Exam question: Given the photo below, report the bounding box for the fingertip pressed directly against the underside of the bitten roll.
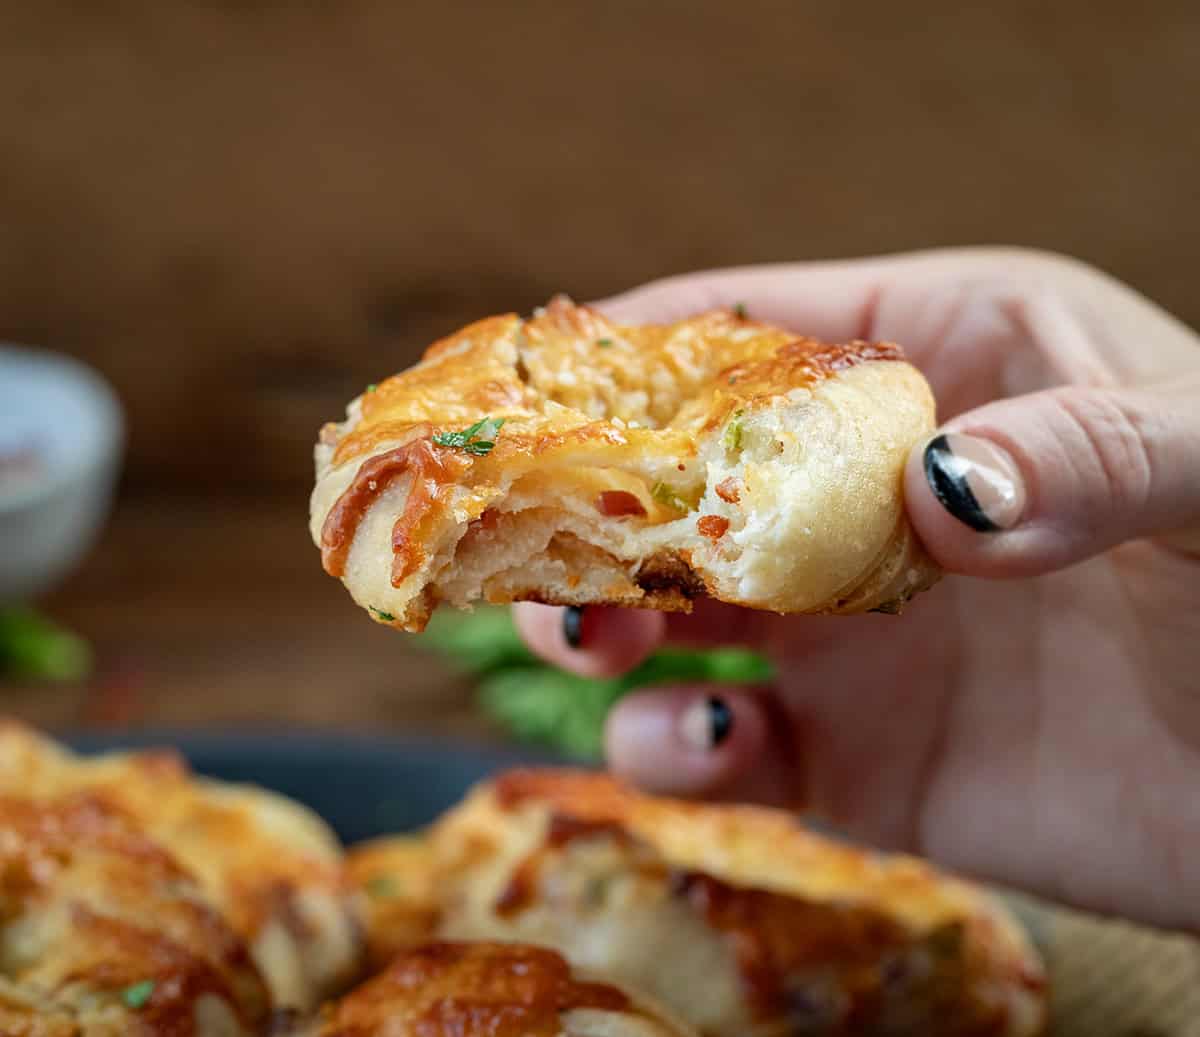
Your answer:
[512,604,666,677]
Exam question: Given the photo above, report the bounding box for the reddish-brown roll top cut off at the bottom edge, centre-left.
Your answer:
[296,943,691,1037]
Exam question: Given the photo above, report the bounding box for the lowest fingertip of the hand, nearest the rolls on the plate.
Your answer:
[605,688,802,807]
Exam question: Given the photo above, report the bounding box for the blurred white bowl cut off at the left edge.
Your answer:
[0,344,124,605]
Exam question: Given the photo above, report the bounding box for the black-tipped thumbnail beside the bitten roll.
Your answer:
[924,432,1025,533]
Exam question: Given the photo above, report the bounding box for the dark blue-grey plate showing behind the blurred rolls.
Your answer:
[62,731,553,843]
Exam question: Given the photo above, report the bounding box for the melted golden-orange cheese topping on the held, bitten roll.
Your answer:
[320,298,904,587]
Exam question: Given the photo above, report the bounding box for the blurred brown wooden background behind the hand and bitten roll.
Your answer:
[0,0,1200,733]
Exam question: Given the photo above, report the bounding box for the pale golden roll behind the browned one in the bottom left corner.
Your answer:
[0,723,362,1009]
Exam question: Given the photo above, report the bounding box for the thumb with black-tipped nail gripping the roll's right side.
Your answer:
[905,377,1200,576]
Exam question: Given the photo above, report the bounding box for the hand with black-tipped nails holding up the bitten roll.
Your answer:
[517,250,1200,928]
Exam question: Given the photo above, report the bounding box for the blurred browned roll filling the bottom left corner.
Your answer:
[0,792,271,1037]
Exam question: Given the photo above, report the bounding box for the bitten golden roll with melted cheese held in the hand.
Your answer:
[311,298,937,630]
